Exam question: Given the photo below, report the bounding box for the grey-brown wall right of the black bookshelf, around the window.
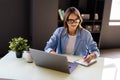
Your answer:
[99,0,120,49]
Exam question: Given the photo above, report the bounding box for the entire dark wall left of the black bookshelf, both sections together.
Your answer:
[0,0,58,57]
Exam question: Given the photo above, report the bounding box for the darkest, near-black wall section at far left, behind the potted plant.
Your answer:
[0,0,30,57]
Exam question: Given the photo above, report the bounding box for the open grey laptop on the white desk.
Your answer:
[30,48,78,74]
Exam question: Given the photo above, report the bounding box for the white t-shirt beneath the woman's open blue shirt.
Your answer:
[66,35,76,54]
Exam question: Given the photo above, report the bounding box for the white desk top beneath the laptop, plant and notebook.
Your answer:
[0,52,120,80]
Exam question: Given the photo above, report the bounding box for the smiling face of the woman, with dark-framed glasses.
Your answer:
[67,13,80,31]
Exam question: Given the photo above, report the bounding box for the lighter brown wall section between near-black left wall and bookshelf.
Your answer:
[31,0,58,50]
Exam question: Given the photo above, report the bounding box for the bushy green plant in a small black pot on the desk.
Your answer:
[9,37,30,58]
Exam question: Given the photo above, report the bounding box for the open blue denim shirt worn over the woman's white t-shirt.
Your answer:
[44,27,100,56]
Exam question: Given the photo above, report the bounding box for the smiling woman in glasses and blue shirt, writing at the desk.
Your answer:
[44,7,100,63]
